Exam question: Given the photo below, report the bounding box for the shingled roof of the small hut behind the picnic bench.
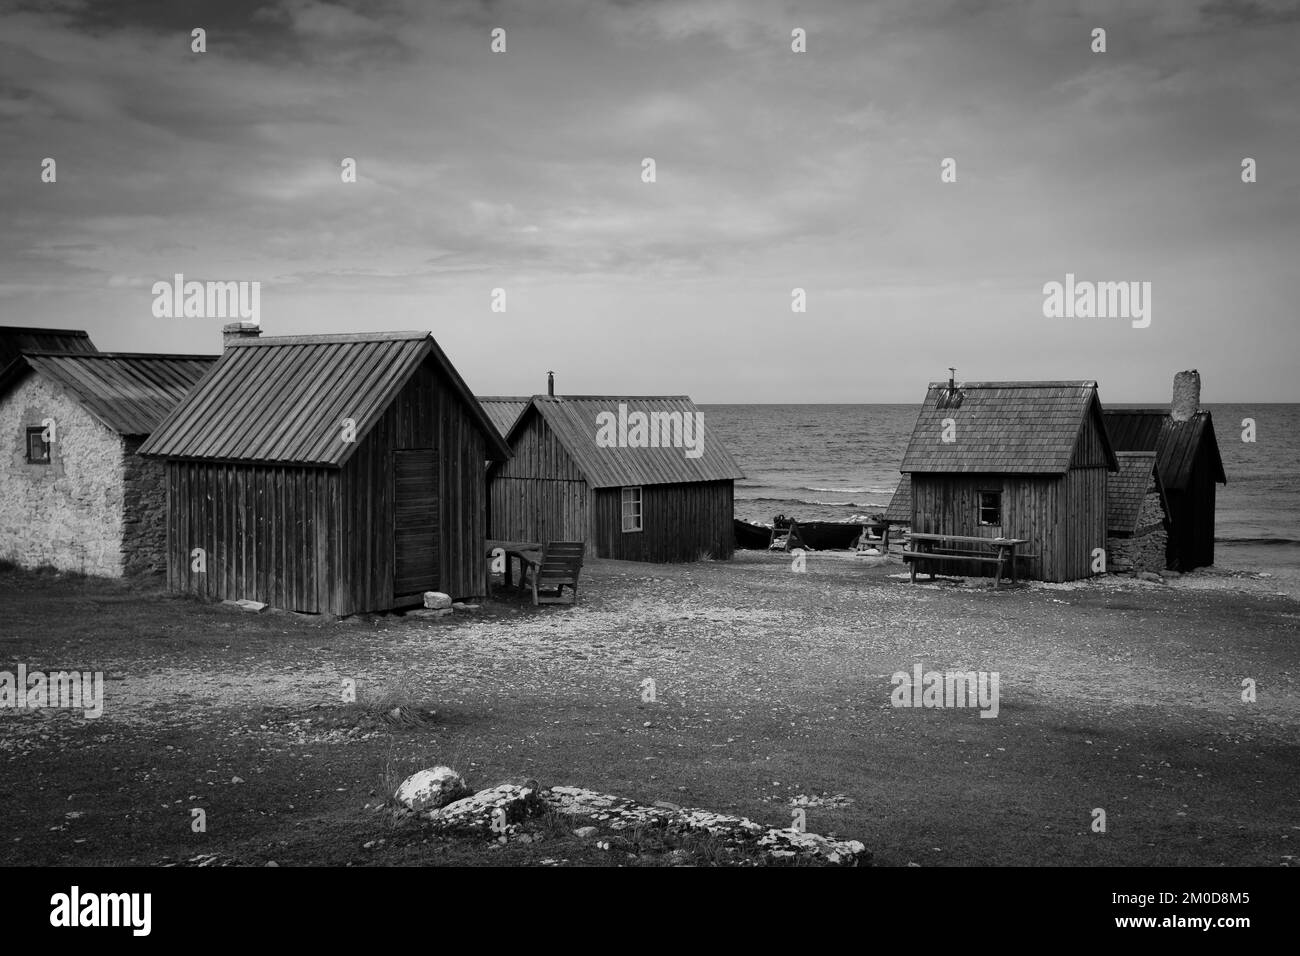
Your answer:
[900,381,1118,475]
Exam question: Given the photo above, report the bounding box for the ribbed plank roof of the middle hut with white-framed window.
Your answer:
[506,395,745,488]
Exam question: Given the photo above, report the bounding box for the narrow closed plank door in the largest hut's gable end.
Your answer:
[393,449,439,597]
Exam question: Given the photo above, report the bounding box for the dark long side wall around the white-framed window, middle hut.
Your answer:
[588,481,736,562]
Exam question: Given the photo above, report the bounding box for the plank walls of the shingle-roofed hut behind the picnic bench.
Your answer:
[911,468,1106,581]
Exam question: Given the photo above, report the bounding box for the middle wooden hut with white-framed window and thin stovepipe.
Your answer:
[488,395,744,562]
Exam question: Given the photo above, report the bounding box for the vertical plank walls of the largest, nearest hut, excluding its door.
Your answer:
[166,356,488,614]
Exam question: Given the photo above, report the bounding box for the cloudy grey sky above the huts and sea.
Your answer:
[0,0,1300,405]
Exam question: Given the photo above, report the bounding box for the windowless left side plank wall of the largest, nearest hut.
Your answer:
[166,462,339,613]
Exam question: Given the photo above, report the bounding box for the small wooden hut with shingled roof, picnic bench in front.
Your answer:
[900,380,1118,581]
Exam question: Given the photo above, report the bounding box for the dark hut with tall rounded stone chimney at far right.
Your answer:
[1106,371,1227,571]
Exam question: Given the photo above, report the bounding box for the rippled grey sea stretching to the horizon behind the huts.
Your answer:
[701,405,1300,581]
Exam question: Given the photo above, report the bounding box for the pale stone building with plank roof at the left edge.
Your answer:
[0,351,216,578]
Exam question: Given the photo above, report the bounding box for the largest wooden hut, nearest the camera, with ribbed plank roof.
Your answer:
[142,332,508,615]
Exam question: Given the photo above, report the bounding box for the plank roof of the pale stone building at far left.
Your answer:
[0,351,217,434]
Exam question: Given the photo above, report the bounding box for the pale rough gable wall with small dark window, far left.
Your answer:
[0,375,125,578]
